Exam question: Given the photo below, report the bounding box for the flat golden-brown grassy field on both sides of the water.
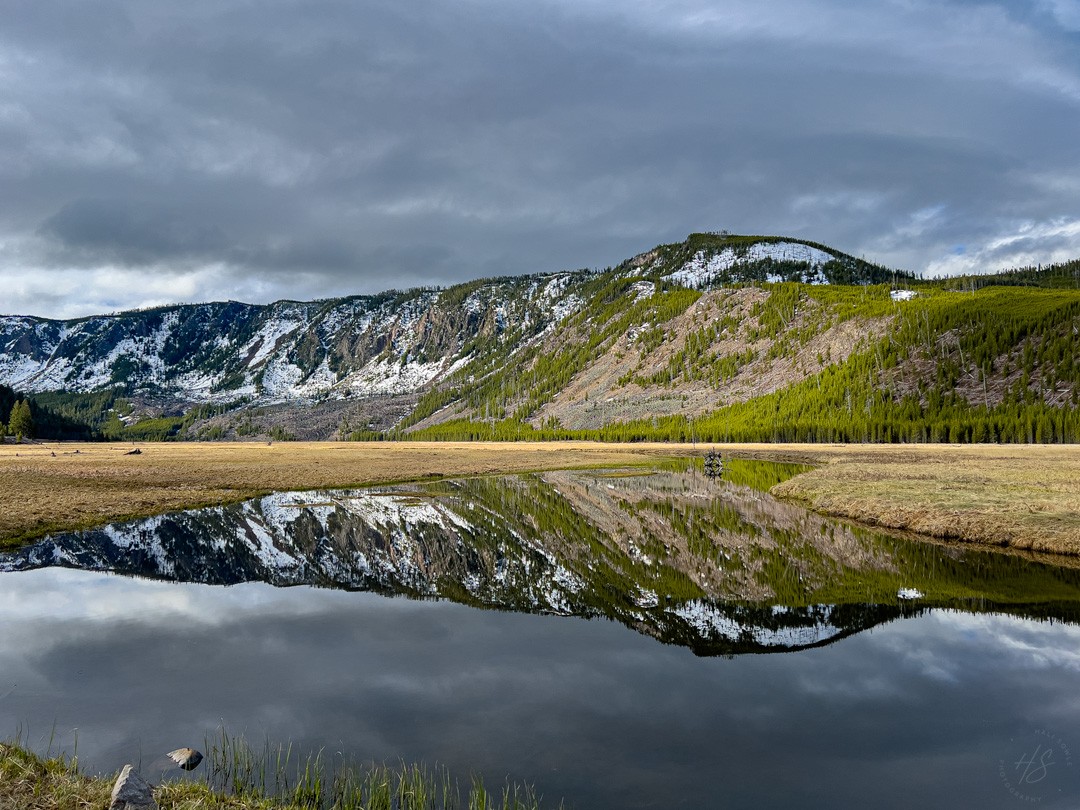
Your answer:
[0,442,1080,554]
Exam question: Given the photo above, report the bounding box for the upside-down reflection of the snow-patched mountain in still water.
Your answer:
[8,462,1080,656]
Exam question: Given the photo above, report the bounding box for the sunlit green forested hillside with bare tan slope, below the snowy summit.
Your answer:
[397,262,1080,442]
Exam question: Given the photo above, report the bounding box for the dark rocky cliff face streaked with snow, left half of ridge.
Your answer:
[0,285,548,404]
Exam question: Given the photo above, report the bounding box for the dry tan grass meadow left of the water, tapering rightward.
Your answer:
[0,442,677,545]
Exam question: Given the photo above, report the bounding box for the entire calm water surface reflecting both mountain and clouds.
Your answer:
[0,464,1080,808]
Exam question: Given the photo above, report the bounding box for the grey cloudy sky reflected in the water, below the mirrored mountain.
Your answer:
[0,568,1080,810]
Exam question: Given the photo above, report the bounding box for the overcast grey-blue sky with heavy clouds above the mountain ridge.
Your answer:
[0,0,1080,318]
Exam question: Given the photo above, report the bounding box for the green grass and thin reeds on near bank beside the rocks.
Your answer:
[0,732,540,810]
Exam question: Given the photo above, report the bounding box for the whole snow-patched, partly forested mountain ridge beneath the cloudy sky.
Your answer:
[0,233,1080,441]
